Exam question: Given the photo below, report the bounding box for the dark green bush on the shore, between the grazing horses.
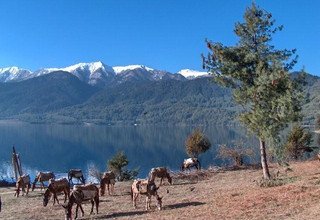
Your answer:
[107,151,139,181]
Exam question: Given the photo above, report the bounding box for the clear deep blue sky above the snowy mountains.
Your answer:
[0,0,320,75]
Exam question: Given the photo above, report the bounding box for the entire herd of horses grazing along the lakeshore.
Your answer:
[11,158,201,220]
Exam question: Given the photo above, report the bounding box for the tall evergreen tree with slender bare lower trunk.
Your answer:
[203,3,302,179]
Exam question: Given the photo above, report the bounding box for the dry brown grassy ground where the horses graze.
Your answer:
[0,161,320,220]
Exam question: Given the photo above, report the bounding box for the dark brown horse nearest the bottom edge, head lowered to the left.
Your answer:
[62,184,99,220]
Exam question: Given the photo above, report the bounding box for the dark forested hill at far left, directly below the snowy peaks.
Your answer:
[0,71,97,118]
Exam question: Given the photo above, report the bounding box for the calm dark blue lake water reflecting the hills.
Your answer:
[0,122,258,178]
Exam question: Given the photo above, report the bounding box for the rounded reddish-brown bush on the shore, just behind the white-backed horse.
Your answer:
[185,129,211,157]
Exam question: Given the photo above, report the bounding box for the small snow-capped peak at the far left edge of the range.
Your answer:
[0,66,32,82]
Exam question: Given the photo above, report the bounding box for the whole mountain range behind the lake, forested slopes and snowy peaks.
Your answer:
[0,62,320,125]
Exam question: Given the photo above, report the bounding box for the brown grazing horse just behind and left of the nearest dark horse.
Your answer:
[43,178,70,206]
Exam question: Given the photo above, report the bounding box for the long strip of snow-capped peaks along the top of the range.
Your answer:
[0,61,208,87]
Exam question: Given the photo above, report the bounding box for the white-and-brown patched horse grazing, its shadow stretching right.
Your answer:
[131,180,162,210]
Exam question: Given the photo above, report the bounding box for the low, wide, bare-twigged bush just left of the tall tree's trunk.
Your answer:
[218,144,254,166]
